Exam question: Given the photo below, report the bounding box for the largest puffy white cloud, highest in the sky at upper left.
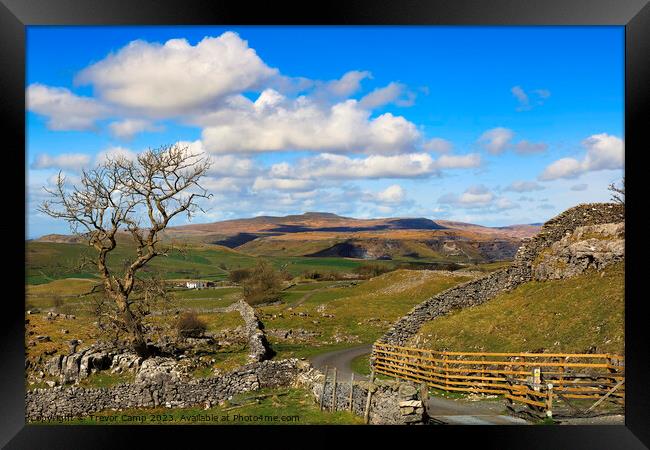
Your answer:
[77,32,278,117]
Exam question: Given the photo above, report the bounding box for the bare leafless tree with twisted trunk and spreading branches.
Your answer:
[39,145,210,357]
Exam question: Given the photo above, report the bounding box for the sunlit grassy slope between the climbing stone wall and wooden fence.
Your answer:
[415,263,625,355]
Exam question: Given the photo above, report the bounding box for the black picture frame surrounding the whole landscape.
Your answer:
[0,0,650,450]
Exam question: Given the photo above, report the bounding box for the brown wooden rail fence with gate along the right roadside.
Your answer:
[371,343,625,416]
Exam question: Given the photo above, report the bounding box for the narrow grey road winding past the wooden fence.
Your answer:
[310,344,528,425]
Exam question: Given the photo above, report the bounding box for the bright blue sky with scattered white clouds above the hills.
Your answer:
[26,26,624,238]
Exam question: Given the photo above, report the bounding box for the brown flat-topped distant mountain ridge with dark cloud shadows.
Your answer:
[39,212,539,262]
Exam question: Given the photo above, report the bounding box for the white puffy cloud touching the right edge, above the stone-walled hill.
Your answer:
[539,133,625,181]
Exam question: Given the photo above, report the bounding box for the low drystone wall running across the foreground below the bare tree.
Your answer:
[25,358,305,421]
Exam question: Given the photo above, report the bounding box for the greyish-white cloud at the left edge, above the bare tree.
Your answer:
[25,83,108,130]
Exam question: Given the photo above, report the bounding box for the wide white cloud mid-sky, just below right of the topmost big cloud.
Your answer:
[199,89,420,154]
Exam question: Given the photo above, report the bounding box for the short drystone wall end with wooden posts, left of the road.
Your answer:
[296,367,427,425]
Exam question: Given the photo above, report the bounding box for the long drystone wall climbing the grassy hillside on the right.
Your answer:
[378,203,625,345]
